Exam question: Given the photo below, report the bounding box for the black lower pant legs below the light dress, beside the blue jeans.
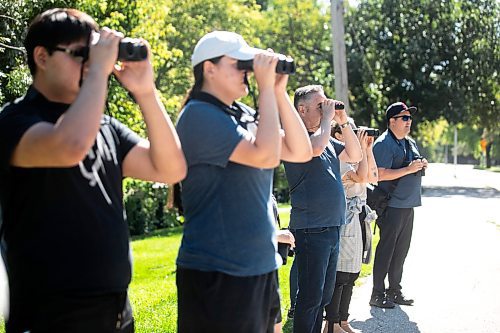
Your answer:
[325,272,359,323]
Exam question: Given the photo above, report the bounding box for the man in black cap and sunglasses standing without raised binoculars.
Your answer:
[370,102,427,308]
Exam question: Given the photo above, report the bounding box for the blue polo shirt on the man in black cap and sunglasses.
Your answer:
[373,130,422,208]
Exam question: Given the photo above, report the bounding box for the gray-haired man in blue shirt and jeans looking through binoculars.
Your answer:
[284,85,362,333]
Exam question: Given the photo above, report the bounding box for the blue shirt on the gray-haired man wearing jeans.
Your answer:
[284,138,346,229]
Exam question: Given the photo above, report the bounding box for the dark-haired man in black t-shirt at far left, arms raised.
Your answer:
[0,9,186,333]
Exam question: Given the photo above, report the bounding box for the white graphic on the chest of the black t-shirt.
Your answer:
[78,131,118,205]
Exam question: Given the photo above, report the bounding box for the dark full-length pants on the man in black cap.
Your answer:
[373,207,413,295]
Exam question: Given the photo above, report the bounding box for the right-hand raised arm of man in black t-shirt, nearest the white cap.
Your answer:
[114,41,187,183]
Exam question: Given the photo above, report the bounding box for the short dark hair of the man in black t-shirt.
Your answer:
[24,8,99,75]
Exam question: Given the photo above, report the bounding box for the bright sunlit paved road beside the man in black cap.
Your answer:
[349,164,500,333]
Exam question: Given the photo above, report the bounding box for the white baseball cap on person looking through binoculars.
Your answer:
[191,31,264,67]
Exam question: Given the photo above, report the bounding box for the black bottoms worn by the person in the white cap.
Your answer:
[176,267,280,333]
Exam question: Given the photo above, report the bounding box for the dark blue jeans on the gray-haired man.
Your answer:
[292,226,340,333]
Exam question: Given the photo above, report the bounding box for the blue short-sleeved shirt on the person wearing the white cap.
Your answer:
[177,100,281,276]
